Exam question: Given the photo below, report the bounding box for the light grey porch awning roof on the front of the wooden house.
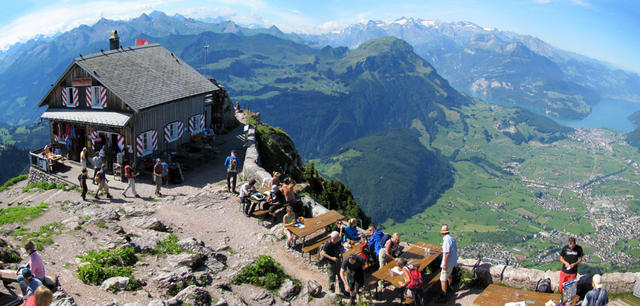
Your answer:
[40,108,131,128]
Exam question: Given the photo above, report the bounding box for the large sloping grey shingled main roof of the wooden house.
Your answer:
[74,44,218,111]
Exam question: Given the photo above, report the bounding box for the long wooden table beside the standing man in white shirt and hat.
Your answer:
[372,242,442,288]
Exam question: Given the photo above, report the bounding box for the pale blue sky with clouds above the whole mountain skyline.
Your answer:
[0,0,640,72]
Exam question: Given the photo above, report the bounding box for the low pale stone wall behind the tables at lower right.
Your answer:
[458,259,640,293]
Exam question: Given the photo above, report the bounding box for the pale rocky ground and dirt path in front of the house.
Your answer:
[0,116,488,305]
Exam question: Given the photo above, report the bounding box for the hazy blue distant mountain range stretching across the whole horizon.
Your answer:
[0,12,640,124]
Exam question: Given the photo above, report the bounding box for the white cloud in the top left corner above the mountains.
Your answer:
[0,0,167,50]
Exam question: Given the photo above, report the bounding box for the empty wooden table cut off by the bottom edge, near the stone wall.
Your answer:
[473,284,560,306]
